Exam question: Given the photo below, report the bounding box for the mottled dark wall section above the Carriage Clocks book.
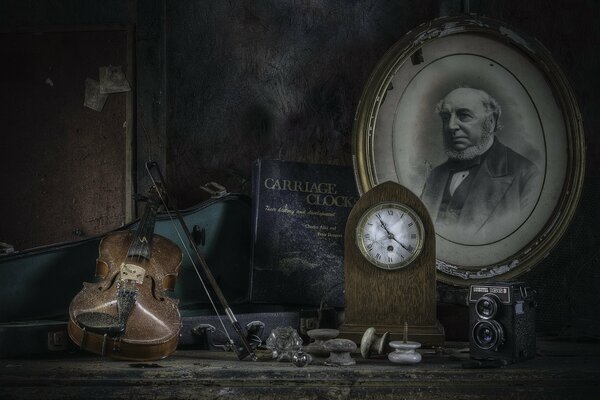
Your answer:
[166,0,435,205]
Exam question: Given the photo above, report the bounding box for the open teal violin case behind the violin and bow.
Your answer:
[0,193,290,357]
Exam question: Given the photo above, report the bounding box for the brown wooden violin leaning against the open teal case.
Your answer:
[68,185,182,361]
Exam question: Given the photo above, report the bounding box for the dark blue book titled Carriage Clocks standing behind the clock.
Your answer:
[251,160,358,307]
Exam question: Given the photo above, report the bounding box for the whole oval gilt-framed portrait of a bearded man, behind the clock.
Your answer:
[353,16,585,286]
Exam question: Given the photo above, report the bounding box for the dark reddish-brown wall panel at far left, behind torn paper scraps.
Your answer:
[0,1,135,250]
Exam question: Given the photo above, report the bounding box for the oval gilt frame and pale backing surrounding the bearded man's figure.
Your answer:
[353,16,585,286]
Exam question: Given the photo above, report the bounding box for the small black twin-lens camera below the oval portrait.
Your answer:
[469,282,536,365]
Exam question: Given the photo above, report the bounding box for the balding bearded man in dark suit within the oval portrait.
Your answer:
[421,87,543,243]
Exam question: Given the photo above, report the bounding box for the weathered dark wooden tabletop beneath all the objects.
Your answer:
[0,342,600,399]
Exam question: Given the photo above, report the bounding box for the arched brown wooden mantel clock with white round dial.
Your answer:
[340,181,444,346]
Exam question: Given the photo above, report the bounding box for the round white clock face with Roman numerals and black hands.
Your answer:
[356,202,424,269]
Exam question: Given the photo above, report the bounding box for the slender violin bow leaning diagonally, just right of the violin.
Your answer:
[146,161,258,361]
